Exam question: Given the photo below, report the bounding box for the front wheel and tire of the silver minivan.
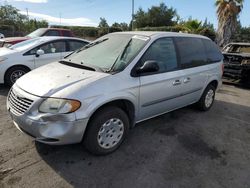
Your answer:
[83,106,129,155]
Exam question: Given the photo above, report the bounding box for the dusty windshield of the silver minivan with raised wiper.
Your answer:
[65,34,149,71]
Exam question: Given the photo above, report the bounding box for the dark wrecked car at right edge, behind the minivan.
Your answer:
[223,43,250,83]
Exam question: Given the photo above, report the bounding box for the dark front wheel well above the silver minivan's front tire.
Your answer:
[89,99,135,127]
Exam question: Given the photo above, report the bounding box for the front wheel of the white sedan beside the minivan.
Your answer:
[4,66,30,86]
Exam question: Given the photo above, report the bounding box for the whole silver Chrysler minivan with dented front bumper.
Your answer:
[7,32,223,155]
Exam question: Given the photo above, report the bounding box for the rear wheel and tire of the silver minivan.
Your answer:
[197,84,215,111]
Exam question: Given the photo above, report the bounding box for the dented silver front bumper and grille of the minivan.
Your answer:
[7,85,88,145]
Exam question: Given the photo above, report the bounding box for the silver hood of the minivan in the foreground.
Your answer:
[16,62,108,97]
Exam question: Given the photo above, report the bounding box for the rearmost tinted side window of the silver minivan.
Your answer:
[202,39,223,63]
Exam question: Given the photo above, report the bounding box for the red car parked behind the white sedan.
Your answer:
[0,28,74,47]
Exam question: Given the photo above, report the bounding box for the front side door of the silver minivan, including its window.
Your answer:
[139,38,185,121]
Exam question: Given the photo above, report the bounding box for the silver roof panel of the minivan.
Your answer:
[112,31,208,39]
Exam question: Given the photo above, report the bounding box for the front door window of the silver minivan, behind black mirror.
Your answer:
[140,38,178,72]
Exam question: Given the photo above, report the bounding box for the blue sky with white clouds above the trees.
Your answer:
[0,0,250,28]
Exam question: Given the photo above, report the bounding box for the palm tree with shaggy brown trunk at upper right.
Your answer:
[215,0,244,46]
